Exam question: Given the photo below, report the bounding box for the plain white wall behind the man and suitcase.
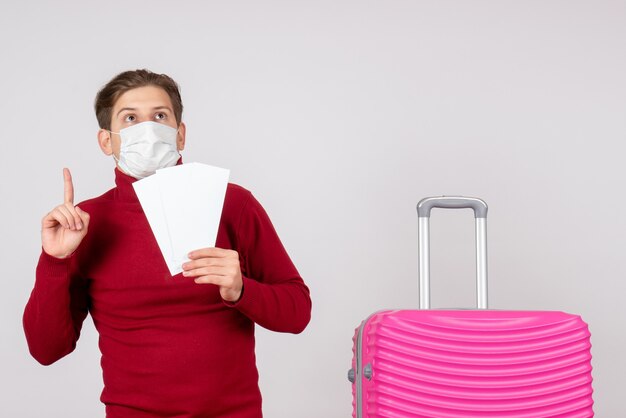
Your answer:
[0,0,626,418]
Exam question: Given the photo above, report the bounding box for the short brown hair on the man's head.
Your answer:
[94,69,183,129]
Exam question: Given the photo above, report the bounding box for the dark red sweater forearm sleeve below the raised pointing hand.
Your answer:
[23,251,89,365]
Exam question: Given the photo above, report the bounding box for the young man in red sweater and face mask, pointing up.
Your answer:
[24,70,311,418]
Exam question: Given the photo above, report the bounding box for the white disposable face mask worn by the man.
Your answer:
[109,121,180,179]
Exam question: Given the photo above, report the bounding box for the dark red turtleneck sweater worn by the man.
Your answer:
[24,165,311,418]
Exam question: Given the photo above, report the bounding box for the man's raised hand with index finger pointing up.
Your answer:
[41,168,89,258]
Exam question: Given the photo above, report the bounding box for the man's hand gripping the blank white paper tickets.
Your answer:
[183,248,243,302]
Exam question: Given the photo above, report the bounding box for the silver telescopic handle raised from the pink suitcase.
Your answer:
[417,196,488,309]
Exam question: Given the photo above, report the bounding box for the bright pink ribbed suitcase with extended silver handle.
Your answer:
[348,197,594,418]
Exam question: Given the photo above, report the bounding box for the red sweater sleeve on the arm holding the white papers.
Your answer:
[225,194,311,334]
